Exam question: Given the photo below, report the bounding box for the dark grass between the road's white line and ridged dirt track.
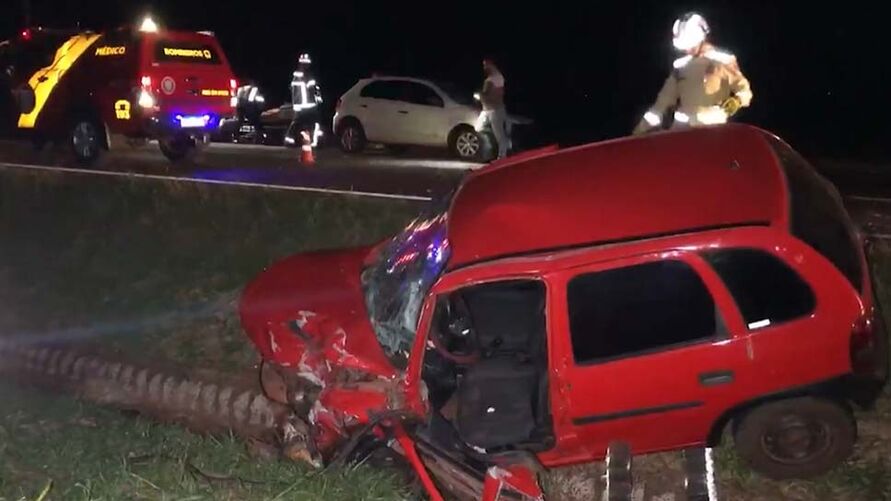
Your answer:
[0,172,418,366]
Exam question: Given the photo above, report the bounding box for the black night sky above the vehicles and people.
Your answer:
[0,0,891,160]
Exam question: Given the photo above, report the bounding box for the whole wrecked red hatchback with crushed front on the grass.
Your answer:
[240,125,887,499]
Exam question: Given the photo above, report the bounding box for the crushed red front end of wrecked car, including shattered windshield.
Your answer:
[240,199,528,500]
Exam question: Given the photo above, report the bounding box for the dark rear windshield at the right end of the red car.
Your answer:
[770,137,863,291]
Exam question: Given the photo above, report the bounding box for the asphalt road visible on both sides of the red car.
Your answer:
[0,141,891,233]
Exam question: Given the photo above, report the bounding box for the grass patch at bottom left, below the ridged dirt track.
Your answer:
[0,380,404,501]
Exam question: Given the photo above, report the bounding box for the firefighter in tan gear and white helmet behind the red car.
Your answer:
[634,13,752,134]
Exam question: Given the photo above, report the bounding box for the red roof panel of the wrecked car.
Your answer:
[448,124,788,269]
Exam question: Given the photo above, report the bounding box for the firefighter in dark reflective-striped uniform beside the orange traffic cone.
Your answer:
[285,53,322,148]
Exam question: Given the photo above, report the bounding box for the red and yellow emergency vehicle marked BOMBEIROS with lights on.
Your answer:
[7,20,237,164]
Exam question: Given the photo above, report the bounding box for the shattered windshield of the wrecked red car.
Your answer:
[362,197,449,368]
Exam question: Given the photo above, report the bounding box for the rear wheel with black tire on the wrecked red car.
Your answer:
[734,397,857,480]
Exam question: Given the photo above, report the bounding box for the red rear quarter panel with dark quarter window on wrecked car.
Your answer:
[703,246,840,398]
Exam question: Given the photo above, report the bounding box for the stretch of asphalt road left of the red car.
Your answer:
[0,141,479,198]
